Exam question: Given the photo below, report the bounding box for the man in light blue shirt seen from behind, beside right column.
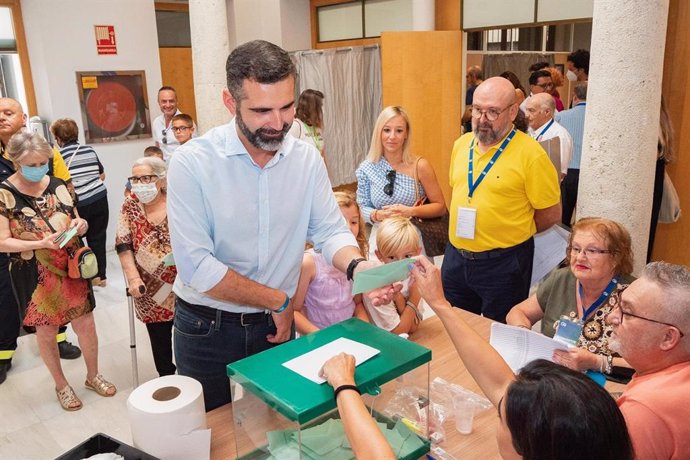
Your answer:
[554,81,587,227]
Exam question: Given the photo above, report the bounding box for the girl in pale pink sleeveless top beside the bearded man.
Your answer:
[293,192,369,335]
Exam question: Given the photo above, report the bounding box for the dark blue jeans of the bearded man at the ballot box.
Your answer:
[174,297,294,411]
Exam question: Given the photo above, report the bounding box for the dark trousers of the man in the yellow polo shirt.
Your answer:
[441,238,534,323]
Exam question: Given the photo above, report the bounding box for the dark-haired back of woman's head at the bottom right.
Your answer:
[502,359,633,460]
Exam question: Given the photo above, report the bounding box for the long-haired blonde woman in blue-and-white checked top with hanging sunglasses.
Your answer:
[356,107,446,258]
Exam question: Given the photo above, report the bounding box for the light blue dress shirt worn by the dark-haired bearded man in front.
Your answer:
[167,120,357,313]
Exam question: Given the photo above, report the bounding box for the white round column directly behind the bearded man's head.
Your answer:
[189,0,231,133]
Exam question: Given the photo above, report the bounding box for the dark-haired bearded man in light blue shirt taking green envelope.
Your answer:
[167,41,392,410]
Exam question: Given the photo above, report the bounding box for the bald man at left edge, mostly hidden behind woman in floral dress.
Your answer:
[0,97,81,384]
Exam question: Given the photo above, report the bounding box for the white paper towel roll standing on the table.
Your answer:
[127,375,211,460]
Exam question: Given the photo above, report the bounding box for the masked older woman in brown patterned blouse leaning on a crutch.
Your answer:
[115,157,177,376]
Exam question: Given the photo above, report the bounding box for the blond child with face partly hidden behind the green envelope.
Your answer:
[364,216,422,334]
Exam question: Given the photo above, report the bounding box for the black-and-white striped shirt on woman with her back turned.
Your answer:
[60,142,106,206]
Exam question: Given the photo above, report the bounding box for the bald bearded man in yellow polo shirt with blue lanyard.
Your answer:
[442,77,561,322]
